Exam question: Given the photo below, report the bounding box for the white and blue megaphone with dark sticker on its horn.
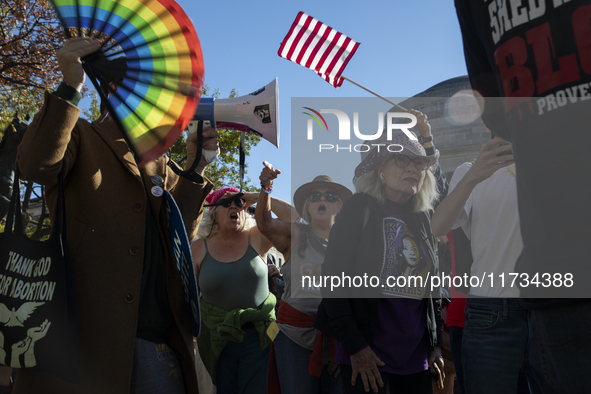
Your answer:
[189,78,279,158]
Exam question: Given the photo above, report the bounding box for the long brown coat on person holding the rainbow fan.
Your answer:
[14,94,212,394]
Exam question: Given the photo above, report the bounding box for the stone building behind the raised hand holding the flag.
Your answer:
[392,76,490,181]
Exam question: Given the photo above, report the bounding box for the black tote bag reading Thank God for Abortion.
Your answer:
[0,168,79,382]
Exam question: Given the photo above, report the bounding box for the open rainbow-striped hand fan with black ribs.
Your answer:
[52,0,203,167]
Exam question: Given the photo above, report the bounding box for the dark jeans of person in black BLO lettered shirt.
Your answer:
[530,300,591,394]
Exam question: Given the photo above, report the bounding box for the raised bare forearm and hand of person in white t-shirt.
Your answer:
[431,137,514,237]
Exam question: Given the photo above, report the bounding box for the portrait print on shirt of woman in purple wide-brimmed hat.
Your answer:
[380,217,431,299]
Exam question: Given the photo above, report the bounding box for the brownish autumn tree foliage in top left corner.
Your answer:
[0,0,63,130]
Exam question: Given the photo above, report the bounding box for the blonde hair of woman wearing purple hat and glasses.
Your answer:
[353,161,439,212]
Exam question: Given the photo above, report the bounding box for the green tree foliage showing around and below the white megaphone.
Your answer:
[171,85,261,191]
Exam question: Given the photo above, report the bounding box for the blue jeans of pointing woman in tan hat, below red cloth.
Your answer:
[273,332,343,394]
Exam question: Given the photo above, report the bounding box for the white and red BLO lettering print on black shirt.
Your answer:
[486,0,591,121]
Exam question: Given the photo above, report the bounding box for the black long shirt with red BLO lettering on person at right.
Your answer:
[455,0,591,298]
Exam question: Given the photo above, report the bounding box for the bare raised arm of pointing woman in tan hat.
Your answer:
[255,162,297,258]
